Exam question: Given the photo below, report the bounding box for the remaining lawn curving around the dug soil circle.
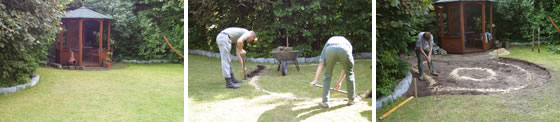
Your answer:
[376,46,560,121]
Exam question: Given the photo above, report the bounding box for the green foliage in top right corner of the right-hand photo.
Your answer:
[494,0,560,43]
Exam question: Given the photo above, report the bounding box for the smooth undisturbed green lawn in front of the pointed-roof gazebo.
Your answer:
[0,64,184,121]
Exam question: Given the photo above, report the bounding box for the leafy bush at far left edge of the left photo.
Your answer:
[0,0,63,87]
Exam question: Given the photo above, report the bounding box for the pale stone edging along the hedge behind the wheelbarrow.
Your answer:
[188,50,372,64]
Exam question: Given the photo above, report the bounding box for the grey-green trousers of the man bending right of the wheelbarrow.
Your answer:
[323,46,356,102]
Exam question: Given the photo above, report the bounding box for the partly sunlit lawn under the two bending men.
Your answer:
[187,55,372,122]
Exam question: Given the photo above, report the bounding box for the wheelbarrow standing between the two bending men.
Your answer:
[270,50,300,76]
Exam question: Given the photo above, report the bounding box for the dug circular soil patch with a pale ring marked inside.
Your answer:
[401,53,550,97]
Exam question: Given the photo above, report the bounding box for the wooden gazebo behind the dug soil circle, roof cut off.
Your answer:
[434,0,495,53]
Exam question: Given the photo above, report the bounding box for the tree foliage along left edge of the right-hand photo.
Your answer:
[376,0,434,96]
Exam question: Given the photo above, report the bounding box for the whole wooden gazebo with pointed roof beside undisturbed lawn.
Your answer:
[56,7,111,67]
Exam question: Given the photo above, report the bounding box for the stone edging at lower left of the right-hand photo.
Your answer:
[375,71,412,110]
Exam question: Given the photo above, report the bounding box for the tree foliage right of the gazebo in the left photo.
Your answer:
[69,0,184,62]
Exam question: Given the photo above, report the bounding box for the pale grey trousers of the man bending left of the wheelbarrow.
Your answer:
[216,33,233,78]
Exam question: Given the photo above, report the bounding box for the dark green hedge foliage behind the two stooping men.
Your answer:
[188,0,372,57]
